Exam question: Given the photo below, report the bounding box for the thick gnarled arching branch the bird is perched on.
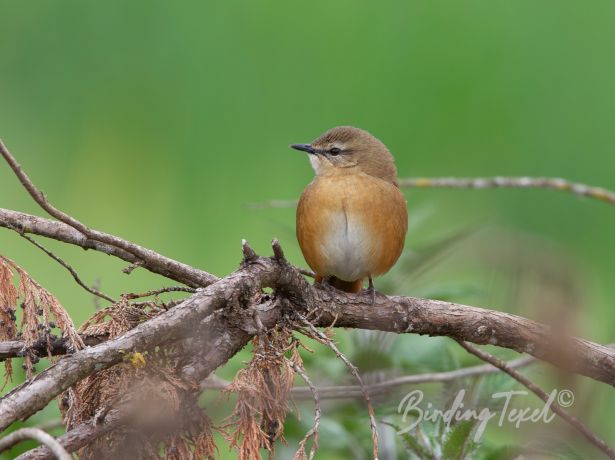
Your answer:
[0,246,615,430]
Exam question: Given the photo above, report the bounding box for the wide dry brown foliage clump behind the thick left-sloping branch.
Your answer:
[60,296,216,460]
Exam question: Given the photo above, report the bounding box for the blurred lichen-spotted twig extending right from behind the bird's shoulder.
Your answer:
[399,177,615,205]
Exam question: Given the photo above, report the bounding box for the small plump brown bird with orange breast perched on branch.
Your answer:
[291,126,408,294]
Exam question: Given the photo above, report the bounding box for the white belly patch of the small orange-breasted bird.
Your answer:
[321,212,376,281]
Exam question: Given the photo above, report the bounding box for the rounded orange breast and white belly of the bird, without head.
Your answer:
[297,172,407,281]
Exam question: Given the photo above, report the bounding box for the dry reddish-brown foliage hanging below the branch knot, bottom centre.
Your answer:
[222,326,302,460]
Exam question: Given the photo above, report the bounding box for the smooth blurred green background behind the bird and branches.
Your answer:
[0,0,615,458]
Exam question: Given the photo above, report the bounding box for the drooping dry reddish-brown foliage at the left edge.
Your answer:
[0,255,84,390]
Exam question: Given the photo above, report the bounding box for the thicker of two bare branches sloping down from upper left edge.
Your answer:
[0,208,218,287]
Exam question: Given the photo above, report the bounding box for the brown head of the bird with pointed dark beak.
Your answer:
[291,126,397,184]
